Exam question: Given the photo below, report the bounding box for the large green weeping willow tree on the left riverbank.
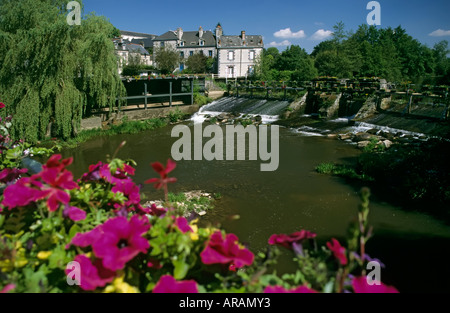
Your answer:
[0,0,125,142]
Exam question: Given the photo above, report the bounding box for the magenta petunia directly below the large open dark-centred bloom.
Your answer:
[66,255,115,291]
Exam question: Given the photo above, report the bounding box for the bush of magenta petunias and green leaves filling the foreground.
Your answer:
[0,103,397,293]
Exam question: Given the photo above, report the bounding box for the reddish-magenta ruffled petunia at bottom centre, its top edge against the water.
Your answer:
[200,230,255,268]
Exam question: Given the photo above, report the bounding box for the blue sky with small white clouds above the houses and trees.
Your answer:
[83,0,450,52]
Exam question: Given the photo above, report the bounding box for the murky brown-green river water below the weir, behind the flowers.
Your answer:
[63,123,450,292]
